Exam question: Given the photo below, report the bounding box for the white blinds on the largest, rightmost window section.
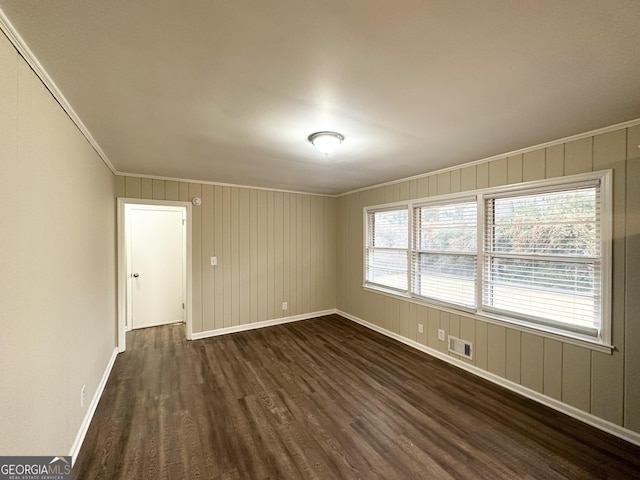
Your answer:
[483,185,602,336]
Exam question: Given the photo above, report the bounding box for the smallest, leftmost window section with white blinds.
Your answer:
[365,207,409,291]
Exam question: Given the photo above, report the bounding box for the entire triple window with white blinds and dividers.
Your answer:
[364,172,611,346]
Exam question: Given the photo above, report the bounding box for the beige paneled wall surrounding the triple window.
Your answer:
[337,126,640,432]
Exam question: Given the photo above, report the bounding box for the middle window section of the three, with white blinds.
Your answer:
[411,198,478,308]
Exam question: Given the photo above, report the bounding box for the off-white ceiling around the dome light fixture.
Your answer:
[0,0,640,194]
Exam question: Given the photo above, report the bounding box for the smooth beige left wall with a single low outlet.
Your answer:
[0,33,116,455]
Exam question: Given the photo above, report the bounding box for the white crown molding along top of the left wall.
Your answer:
[0,8,118,175]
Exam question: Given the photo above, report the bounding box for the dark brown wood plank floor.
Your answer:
[73,316,640,480]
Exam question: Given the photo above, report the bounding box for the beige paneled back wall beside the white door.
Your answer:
[116,177,336,333]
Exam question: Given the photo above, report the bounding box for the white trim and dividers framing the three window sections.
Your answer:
[362,170,614,353]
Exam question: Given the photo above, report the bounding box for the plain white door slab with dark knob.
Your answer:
[128,205,185,328]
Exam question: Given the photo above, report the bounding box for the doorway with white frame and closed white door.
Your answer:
[118,198,191,352]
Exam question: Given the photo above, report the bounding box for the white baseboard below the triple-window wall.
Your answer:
[336,310,640,446]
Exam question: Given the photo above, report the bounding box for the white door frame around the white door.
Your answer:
[117,197,193,352]
